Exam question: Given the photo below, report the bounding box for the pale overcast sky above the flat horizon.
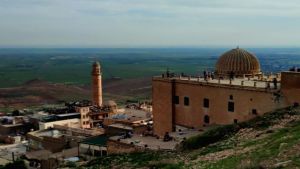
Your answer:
[0,0,300,47]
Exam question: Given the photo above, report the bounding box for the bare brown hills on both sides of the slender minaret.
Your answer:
[0,78,151,111]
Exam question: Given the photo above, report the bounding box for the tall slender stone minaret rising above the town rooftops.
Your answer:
[92,62,102,106]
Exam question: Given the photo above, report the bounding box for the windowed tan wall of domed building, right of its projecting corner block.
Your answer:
[175,83,285,128]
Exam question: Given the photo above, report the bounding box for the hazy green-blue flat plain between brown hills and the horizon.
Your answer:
[0,48,300,87]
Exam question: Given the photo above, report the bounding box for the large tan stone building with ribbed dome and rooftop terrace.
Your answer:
[152,47,300,136]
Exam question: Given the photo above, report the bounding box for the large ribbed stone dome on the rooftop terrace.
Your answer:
[216,48,261,76]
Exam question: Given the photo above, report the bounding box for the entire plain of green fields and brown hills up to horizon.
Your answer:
[0,48,300,111]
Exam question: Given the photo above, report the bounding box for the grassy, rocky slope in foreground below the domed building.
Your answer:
[74,107,300,169]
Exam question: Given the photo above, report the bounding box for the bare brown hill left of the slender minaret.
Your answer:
[0,79,89,109]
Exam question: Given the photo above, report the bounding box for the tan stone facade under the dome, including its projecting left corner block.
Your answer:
[153,78,287,136]
